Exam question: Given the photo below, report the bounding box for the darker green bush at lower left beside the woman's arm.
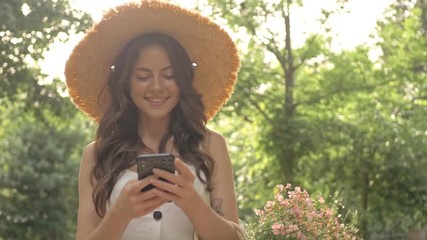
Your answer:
[0,112,86,239]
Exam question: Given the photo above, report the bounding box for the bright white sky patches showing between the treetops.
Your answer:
[39,0,392,79]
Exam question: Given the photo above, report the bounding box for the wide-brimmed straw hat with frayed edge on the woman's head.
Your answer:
[65,1,240,121]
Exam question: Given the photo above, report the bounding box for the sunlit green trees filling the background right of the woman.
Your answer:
[210,0,427,239]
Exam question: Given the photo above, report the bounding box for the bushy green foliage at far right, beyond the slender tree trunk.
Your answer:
[297,8,427,234]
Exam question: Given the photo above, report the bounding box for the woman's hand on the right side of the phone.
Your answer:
[150,158,203,211]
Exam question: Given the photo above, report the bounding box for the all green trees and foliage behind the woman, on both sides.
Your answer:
[0,0,427,240]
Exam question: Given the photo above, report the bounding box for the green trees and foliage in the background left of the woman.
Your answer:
[0,0,92,239]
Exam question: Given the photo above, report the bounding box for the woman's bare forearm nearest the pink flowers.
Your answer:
[187,200,239,240]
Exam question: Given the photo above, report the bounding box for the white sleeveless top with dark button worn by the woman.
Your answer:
[107,166,210,240]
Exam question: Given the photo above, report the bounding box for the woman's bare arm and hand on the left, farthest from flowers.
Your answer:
[76,143,164,240]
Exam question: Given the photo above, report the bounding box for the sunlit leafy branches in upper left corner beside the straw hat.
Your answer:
[0,0,91,108]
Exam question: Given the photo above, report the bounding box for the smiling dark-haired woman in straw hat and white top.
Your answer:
[66,1,244,240]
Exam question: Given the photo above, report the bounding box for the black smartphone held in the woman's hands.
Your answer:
[136,153,175,192]
